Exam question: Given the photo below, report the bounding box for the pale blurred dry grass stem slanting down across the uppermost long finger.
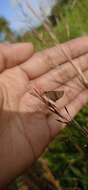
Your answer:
[19,0,88,88]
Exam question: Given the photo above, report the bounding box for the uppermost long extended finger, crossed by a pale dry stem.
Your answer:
[21,37,88,79]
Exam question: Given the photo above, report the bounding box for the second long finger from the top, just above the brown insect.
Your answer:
[29,54,88,93]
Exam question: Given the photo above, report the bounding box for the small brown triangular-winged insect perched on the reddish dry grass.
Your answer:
[43,90,64,102]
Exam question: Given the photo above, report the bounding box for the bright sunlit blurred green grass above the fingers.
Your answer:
[19,0,88,50]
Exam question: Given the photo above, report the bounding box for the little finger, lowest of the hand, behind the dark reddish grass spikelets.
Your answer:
[48,90,88,138]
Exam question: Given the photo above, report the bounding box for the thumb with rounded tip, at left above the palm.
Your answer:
[0,43,34,72]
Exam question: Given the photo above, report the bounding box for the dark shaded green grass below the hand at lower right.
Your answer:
[45,106,88,190]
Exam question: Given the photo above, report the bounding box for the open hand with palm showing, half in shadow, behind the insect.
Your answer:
[0,37,88,188]
